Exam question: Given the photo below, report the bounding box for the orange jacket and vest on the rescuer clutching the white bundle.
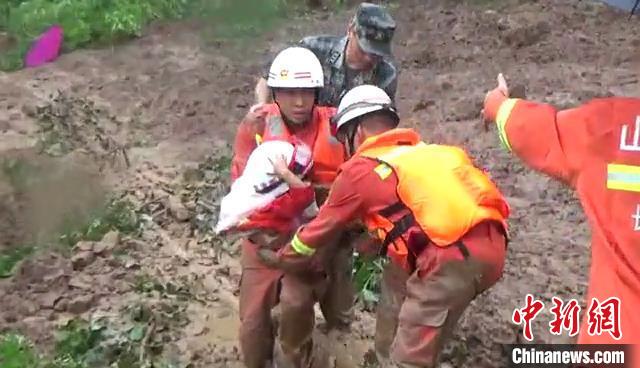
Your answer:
[231,103,345,185]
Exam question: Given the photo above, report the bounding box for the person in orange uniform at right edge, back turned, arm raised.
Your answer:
[484,75,640,350]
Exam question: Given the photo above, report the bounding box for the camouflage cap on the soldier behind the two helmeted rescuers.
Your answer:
[354,3,396,57]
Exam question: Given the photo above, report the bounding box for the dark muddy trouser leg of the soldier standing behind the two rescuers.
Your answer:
[320,231,355,328]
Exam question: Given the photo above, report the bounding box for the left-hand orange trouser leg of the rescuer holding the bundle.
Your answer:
[239,240,282,368]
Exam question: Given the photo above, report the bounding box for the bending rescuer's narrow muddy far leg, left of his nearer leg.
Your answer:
[374,262,409,362]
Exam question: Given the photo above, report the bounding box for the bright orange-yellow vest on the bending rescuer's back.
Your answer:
[356,129,510,269]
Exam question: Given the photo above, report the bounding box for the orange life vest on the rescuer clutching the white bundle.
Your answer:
[256,103,345,185]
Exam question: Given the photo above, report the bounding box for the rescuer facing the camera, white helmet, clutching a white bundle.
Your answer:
[231,47,353,368]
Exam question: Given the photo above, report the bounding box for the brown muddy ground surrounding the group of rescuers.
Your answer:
[0,0,640,367]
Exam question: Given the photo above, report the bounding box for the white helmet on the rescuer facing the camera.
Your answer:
[267,46,324,88]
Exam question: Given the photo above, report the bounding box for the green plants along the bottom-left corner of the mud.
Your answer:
[0,303,185,368]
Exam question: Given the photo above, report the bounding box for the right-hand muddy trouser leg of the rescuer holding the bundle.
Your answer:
[275,274,326,368]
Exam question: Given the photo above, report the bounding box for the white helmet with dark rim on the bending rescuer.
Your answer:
[332,84,398,134]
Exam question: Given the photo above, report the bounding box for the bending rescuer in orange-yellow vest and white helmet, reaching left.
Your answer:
[259,85,509,367]
